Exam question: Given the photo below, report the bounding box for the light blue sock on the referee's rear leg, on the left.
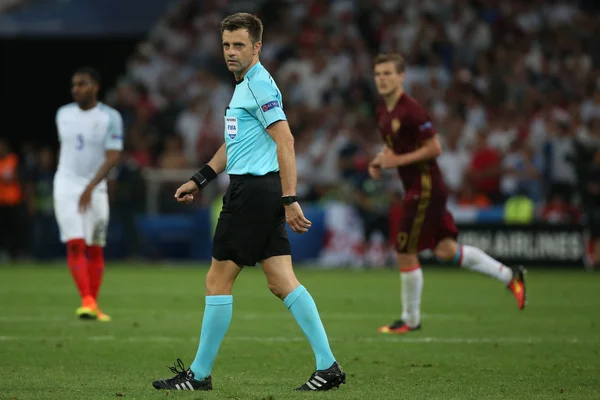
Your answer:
[190,295,233,380]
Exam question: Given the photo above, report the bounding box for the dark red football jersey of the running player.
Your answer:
[377,93,447,196]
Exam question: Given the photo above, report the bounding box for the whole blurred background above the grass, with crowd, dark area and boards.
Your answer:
[0,0,600,268]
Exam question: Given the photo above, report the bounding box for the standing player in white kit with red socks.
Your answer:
[54,68,123,321]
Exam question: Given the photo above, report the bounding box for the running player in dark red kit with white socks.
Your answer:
[369,54,526,334]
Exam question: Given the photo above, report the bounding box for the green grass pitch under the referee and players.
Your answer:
[0,263,600,400]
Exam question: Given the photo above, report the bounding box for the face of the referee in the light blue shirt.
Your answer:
[222,29,261,76]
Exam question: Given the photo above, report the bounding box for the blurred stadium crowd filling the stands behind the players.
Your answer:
[3,0,600,266]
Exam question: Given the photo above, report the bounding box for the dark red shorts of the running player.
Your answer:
[396,193,458,254]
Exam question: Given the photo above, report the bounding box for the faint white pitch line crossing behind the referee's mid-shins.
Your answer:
[0,335,600,344]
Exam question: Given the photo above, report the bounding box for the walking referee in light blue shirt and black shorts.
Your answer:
[152,13,346,390]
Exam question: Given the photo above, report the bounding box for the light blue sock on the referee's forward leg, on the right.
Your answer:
[283,285,335,369]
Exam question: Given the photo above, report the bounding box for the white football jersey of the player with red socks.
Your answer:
[56,103,123,188]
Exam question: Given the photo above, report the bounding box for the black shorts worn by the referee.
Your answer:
[212,172,291,266]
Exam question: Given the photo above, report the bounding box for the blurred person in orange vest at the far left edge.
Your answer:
[0,138,23,261]
